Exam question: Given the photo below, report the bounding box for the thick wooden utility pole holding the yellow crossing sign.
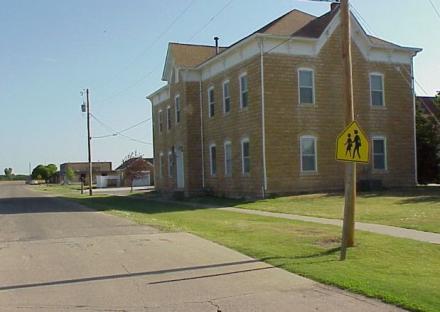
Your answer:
[340,0,356,261]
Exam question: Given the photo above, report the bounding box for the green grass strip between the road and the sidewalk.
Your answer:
[35,188,440,312]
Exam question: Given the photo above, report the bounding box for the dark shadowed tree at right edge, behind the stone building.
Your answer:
[416,93,440,184]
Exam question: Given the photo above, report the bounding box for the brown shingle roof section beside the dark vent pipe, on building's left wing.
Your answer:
[170,42,225,67]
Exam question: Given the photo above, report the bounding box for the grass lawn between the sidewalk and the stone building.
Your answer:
[190,187,440,233]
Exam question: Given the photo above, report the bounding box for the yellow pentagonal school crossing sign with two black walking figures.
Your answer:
[336,121,370,163]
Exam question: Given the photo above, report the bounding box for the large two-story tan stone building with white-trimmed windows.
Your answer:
[147,5,420,197]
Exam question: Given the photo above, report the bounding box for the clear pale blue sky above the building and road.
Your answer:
[0,0,440,173]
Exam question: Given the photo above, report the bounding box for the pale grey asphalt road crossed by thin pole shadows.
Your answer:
[0,183,402,312]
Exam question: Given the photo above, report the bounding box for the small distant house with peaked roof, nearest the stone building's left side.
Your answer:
[115,157,154,186]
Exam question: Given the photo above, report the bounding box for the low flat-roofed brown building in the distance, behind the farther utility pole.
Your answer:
[60,162,114,184]
